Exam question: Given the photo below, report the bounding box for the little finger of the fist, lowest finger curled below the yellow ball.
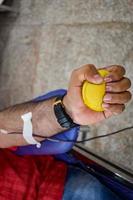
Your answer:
[102,103,125,118]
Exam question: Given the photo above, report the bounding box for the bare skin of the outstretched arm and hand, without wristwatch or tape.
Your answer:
[0,64,131,148]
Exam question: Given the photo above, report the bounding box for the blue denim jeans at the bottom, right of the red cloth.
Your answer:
[63,166,120,200]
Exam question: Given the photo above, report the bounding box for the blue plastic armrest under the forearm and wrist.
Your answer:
[15,89,80,155]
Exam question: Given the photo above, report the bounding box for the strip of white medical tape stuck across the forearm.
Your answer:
[21,112,41,148]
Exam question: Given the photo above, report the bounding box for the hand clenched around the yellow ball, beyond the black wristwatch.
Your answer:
[63,64,132,125]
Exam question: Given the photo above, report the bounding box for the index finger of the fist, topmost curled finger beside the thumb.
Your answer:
[104,65,125,82]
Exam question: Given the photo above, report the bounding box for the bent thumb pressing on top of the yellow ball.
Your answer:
[70,64,103,86]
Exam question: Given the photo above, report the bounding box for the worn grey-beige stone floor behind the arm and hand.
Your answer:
[0,0,133,172]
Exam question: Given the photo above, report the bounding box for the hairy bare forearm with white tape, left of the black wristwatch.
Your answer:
[0,99,65,148]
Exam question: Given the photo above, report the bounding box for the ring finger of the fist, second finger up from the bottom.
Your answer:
[103,91,132,104]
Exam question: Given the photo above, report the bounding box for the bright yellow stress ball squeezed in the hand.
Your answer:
[82,69,109,112]
